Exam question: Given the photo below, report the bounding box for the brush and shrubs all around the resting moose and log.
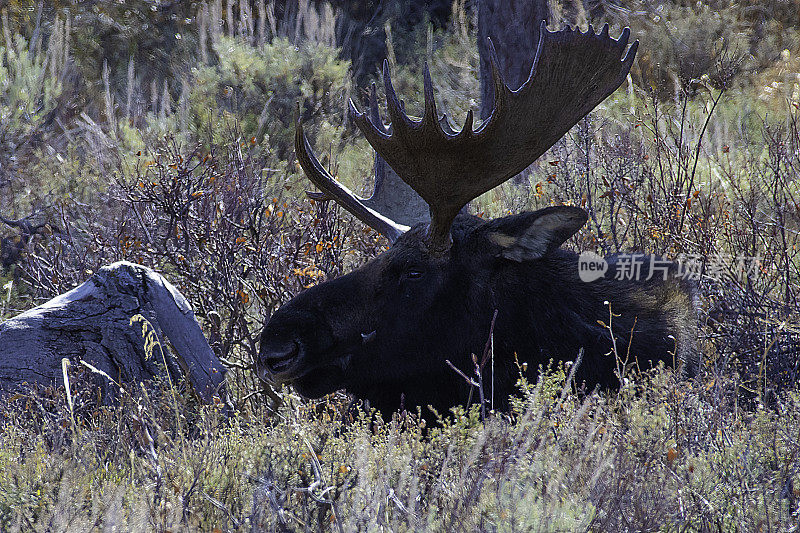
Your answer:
[0,0,800,531]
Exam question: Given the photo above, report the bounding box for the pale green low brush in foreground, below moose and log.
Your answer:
[0,362,800,531]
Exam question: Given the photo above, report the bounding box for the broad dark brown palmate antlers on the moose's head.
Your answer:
[295,22,639,254]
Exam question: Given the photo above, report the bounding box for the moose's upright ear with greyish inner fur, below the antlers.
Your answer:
[487,206,588,262]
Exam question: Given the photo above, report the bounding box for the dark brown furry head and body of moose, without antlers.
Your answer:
[258,207,698,414]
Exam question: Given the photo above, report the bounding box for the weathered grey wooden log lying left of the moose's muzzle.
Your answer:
[0,261,226,402]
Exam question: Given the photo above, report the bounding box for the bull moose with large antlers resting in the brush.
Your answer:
[256,24,698,414]
